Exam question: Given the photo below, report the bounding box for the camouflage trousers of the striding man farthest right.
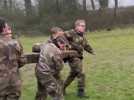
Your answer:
[64,58,85,92]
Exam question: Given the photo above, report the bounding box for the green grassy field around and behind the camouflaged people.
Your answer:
[21,27,134,100]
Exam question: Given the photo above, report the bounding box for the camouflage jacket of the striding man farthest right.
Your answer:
[64,29,93,57]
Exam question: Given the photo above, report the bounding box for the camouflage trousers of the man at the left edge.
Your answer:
[0,74,21,100]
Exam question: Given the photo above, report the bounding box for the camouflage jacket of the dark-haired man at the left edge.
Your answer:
[0,36,23,77]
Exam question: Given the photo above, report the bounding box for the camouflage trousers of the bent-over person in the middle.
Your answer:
[35,67,64,100]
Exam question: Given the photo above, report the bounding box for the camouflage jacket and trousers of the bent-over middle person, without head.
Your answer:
[36,43,63,100]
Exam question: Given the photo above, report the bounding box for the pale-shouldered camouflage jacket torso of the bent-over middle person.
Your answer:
[37,43,63,74]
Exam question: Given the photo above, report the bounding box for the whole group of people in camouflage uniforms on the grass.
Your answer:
[0,19,94,100]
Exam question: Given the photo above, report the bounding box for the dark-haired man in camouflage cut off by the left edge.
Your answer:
[0,18,23,100]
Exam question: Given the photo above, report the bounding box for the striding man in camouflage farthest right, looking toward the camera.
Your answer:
[64,19,94,97]
